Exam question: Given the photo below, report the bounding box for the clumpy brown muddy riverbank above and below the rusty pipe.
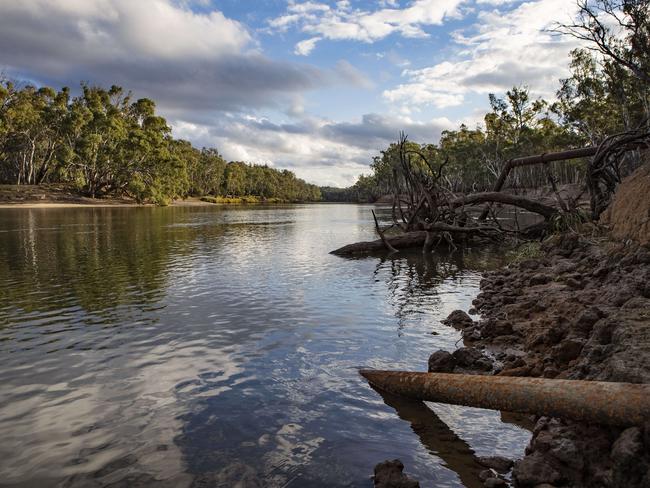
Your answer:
[436,233,650,488]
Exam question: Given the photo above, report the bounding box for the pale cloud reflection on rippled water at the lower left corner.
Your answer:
[0,332,240,487]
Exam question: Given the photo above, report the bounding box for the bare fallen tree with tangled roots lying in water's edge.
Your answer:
[333,130,650,255]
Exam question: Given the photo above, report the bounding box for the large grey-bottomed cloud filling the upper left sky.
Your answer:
[0,0,324,116]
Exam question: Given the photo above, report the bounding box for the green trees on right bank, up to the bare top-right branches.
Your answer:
[324,0,650,201]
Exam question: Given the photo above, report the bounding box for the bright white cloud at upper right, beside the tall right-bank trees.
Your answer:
[383,0,577,108]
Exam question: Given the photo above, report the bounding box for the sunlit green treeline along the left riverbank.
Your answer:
[0,80,321,204]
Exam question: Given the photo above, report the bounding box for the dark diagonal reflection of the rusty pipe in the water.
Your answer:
[376,390,485,488]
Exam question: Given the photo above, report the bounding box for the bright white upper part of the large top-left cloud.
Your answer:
[0,0,251,59]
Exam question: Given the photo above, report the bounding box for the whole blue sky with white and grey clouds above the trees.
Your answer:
[0,0,576,186]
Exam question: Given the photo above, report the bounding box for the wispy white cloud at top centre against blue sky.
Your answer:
[269,0,463,56]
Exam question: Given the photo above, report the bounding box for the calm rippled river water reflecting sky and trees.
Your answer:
[0,204,530,487]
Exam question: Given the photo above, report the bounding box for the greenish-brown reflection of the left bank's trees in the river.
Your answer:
[0,208,223,323]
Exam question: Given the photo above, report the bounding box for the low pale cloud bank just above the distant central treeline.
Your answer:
[174,114,455,186]
